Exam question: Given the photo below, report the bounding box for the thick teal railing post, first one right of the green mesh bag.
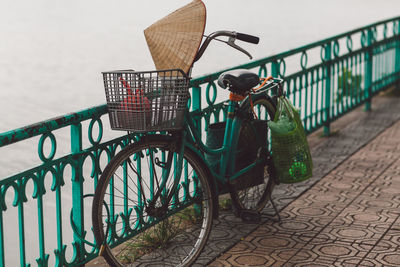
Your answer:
[323,42,332,136]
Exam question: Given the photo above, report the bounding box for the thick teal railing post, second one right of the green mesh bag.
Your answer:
[364,28,373,111]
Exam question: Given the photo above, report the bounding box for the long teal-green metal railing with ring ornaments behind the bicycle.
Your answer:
[0,17,400,266]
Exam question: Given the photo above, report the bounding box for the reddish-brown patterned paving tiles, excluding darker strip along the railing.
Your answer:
[209,93,400,267]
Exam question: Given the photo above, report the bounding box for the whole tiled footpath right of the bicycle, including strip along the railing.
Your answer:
[198,93,400,266]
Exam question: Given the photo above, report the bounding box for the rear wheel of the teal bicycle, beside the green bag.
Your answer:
[230,96,275,215]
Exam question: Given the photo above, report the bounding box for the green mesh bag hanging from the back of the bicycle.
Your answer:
[268,96,313,183]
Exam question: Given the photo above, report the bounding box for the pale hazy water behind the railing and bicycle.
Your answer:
[0,0,400,266]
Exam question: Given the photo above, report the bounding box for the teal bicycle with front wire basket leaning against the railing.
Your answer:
[92,31,283,266]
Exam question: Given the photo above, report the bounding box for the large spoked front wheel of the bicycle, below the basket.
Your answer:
[92,137,213,266]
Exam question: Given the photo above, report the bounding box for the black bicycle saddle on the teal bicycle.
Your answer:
[218,69,260,96]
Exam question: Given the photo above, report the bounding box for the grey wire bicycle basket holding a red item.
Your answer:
[103,70,189,132]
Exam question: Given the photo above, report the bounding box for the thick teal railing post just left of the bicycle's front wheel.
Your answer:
[71,123,85,267]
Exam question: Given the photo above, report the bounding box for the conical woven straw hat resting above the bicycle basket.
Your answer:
[144,0,206,73]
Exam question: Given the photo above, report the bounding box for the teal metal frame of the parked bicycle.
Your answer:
[144,79,282,216]
